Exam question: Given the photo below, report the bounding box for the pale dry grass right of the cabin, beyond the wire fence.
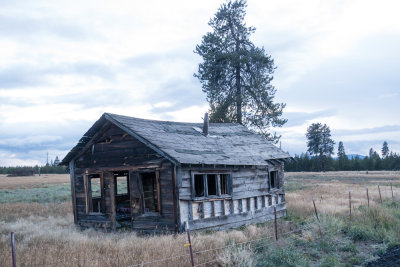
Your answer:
[286,171,400,216]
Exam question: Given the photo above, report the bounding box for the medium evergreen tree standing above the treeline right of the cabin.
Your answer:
[306,123,335,171]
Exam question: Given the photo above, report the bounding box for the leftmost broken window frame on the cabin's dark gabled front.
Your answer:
[84,173,105,215]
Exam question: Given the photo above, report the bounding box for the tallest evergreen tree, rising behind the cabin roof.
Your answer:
[194,0,287,142]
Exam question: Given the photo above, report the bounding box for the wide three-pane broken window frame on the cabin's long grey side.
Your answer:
[191,172,232,199]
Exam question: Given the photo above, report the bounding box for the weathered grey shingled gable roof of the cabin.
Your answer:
[61,113,290,168]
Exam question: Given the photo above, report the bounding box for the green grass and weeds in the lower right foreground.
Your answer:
[252,201,400,266]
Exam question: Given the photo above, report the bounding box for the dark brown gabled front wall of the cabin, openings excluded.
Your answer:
[70,123,177,232]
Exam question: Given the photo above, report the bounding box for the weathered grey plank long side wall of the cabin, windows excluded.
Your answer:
[179,164,286,230]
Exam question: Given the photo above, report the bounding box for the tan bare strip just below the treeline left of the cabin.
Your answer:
[0,174,69,190]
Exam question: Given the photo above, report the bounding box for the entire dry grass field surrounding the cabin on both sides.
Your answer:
[0,172,400,267]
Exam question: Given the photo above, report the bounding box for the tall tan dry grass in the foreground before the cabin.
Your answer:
[0,208,291,266]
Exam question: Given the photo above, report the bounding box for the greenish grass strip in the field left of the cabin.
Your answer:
[0,183,71,204]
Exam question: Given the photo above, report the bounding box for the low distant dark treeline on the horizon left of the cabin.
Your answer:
[0,165,68,176]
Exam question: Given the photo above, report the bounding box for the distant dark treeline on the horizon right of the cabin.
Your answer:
[285,152,400,172]
